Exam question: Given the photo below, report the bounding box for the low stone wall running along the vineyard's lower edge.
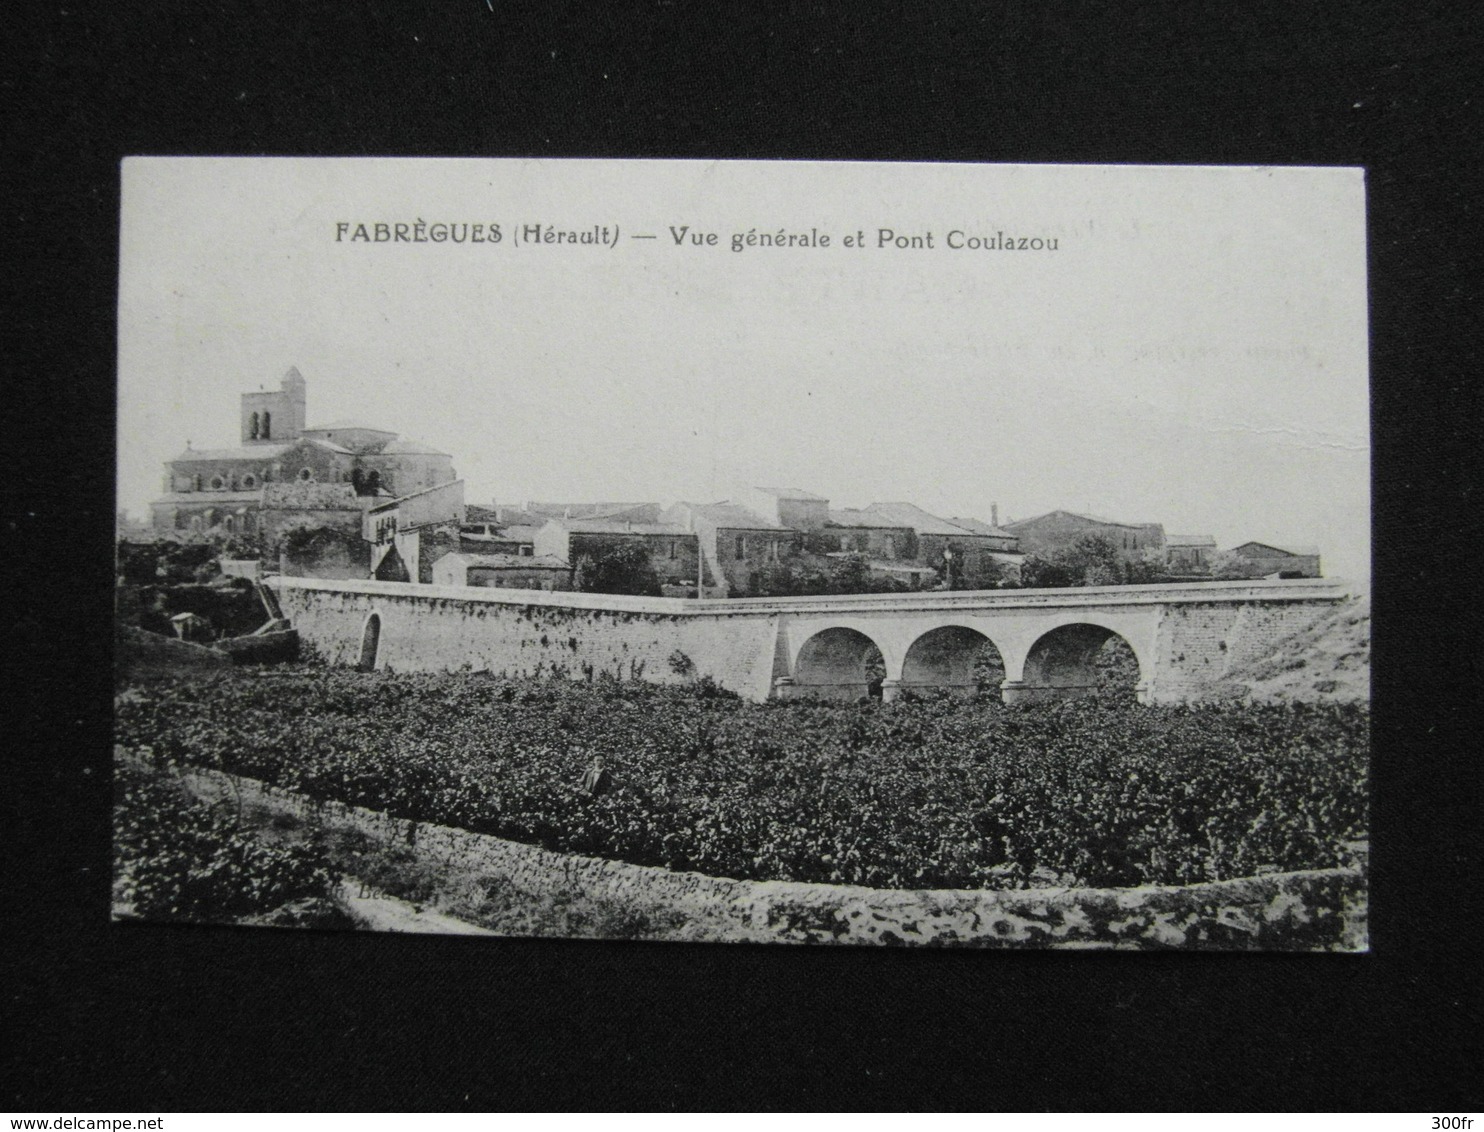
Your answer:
[162,770,1367,951]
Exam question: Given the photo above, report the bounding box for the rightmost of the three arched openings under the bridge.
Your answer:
[1003,619,1152,703]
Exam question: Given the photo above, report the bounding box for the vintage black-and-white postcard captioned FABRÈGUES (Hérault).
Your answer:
[114,157,1370,951]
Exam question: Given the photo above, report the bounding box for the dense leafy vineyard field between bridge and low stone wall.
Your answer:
[116,666,1370,889]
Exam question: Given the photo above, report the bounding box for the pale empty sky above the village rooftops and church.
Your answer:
[119,157,1370,583]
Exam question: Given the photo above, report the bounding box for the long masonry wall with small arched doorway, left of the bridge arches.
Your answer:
[279,586,778,699]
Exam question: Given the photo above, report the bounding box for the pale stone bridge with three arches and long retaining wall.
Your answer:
[270,577,1347,703]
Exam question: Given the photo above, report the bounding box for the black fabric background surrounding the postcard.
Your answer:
[0,0,1484,1113]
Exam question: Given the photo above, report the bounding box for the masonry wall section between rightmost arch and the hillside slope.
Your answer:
[1153,602,1331,700]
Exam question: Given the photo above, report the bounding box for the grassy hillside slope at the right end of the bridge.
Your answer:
[1215,598,1371,703]
